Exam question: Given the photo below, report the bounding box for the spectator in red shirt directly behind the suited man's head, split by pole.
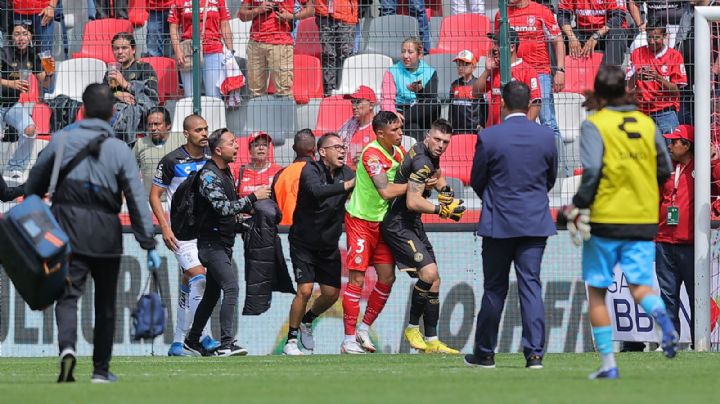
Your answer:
[473,29,542,128]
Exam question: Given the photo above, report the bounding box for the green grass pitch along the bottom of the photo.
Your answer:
[0,352,720,404]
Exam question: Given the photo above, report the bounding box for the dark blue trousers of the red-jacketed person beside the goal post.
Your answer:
[655,241,695,340]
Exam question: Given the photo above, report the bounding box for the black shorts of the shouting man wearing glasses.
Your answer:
[290,242,342,289]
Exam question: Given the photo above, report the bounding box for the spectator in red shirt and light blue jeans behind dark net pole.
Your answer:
[168,0,235,98]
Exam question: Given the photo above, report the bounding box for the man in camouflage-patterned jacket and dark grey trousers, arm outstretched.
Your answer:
[184,128,270,356]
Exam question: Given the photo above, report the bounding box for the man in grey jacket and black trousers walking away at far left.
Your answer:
[25,84,160,383]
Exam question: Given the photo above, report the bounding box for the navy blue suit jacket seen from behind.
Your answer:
[471,116,558,238]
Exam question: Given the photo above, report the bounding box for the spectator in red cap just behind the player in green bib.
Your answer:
[338,86,377,170]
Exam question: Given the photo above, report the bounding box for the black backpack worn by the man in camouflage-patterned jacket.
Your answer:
[170,167,204,241]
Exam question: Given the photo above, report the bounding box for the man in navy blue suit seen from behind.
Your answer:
[465,81,557,369]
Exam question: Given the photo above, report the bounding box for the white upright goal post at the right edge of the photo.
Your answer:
[693,7,720,351]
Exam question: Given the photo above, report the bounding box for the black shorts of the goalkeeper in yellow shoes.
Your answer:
[380,219,436,270]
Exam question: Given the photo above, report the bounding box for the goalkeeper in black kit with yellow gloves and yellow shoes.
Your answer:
[380,119,465,354]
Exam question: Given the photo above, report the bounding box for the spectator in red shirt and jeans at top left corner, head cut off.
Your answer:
[10,0,57,52]
